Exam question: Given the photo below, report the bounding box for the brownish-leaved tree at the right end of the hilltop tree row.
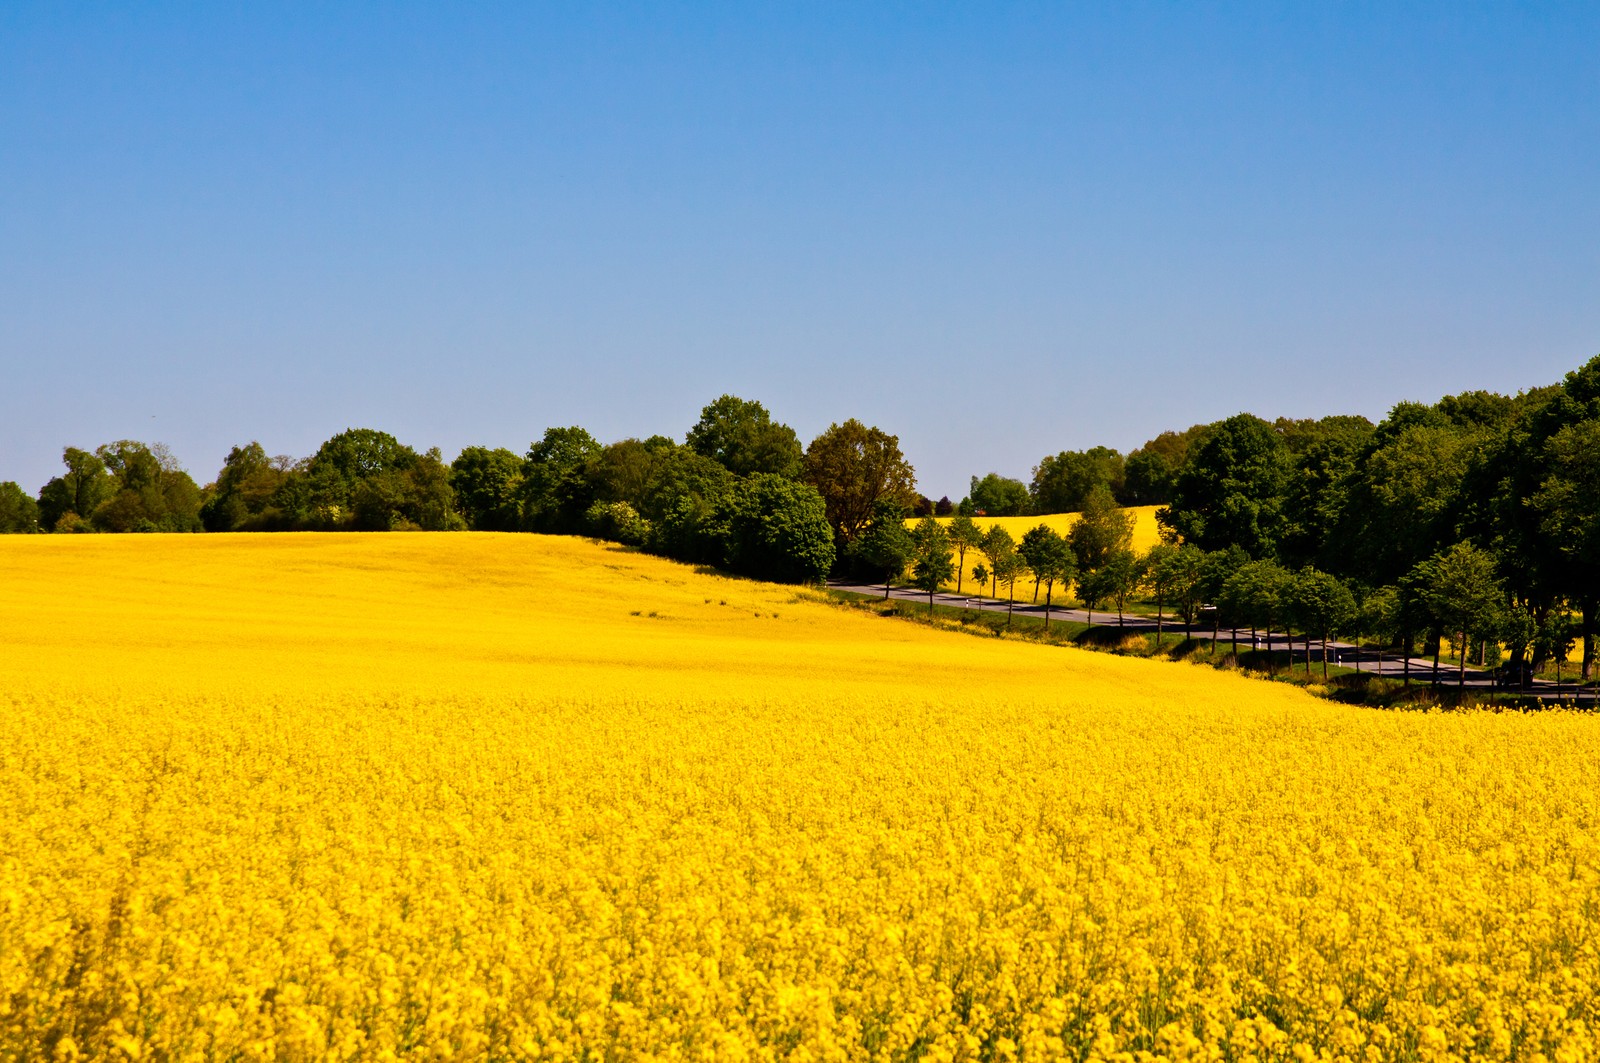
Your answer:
[805,418,917,544]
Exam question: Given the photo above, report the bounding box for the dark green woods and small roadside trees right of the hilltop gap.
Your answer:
[880,357,1600,682]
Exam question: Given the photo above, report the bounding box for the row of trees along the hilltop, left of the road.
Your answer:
[0,395,915,581]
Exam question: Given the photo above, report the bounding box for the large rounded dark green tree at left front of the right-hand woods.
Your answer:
[1157,413,1291,557]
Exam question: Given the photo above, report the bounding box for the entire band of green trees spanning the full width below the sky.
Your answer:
[0,357,1600,679]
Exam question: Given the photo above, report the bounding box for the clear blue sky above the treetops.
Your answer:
[0,0,1600,498]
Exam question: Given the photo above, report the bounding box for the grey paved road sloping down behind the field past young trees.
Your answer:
[827,580,1595,701]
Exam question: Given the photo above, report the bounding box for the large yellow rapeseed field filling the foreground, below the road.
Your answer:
[0,533,1600,1061]
